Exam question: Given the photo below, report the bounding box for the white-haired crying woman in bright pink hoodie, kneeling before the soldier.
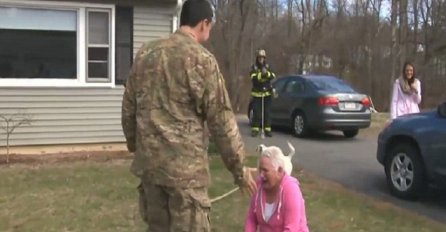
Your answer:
[245,148,309,232]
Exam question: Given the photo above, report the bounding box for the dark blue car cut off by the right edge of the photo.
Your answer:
[377,102,446,200]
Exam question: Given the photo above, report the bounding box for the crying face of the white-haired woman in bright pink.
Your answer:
[259,156,283,190]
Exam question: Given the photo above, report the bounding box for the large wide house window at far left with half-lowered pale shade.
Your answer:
[0,7,77,79]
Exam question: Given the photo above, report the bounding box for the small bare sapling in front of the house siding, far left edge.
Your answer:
[0,112,32,163]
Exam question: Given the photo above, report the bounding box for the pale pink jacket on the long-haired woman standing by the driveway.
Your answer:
[390,79,421,119]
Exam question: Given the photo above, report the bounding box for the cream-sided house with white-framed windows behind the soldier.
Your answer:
[0,0,181,146]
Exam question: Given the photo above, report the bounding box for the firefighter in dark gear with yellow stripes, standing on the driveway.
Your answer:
[250,49,276,137]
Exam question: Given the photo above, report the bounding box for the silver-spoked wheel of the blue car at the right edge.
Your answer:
[385,143,426,200]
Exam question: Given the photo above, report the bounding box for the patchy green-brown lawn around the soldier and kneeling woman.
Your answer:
[0,156,446,232]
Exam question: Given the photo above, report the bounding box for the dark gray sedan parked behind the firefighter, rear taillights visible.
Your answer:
[248,75,371,138]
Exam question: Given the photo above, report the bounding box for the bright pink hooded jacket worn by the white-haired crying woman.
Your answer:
[245,174,309,232]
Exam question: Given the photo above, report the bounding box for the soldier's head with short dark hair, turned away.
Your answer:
[180,0,214,43]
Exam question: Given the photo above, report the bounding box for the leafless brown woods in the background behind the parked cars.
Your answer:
[210,0,446,111]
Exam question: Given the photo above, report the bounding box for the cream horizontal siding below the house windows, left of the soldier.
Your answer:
[0,87,125,146]
